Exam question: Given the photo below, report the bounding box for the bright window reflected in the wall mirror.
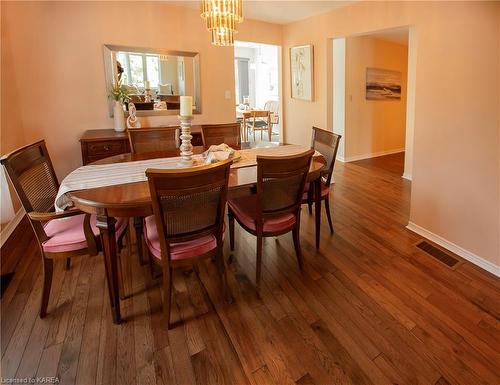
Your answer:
[116,52,160,88]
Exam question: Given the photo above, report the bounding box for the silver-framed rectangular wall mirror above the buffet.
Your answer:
[104,45,201,116]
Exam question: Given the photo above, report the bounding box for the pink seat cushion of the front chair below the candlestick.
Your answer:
[144,215,217,261]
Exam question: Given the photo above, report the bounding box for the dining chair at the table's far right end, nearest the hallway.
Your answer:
[302,127,342,240]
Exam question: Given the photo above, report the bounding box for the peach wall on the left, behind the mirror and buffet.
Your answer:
[1,2,282,178]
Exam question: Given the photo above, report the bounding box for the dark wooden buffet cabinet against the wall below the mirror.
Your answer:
[80,125,203,165]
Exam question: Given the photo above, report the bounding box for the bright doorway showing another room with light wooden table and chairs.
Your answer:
[234,41,282,145]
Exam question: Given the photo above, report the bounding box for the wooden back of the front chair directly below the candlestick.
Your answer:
[146,160,232,263]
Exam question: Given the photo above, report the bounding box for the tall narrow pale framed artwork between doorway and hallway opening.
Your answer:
[290,44,314,101]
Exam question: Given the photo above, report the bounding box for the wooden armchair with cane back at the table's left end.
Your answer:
[0,140,128,318]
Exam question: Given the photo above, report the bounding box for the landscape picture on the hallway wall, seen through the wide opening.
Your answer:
[366,68,401,100]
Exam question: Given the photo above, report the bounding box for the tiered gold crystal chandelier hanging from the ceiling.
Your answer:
[201,0,243,46]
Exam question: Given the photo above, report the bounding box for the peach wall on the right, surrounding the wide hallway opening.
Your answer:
[283,2,500,266]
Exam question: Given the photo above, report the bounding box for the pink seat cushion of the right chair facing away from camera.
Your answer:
[228,195,295,233]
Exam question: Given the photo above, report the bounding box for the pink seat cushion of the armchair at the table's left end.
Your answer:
[42,214,127,253]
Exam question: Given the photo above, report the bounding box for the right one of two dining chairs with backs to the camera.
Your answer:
[228,149,314,291]
